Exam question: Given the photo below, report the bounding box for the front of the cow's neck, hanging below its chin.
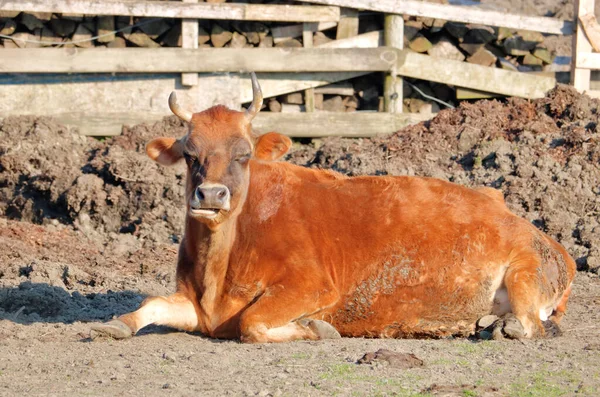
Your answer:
[185,218,236,316]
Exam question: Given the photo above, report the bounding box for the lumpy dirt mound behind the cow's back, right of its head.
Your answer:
[290,86,600,271]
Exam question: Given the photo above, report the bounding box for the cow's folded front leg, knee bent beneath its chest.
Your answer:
[240,286,340,343]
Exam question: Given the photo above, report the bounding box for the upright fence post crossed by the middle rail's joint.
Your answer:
[383,14,404,113]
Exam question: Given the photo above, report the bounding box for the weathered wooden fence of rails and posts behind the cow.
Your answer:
[0,0,598,137]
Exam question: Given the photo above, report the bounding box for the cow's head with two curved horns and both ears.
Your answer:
[146,73,291,227]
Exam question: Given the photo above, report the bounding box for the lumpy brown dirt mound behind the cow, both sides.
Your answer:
[0,86,600,271]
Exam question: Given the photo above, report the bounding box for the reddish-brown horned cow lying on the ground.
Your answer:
[93,74,575,342]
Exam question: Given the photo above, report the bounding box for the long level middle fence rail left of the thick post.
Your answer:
[0,47,398,73]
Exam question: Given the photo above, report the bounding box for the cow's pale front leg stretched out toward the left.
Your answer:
[90,293,198,339]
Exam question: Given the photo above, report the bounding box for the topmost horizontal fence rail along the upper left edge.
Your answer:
[0,0,340,22]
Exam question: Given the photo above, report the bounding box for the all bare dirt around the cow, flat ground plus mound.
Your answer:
[0,86,600,396]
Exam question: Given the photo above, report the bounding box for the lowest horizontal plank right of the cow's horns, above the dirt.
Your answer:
[252,112,432,138]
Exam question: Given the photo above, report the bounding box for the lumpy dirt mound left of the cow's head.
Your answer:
[0,113,185,243]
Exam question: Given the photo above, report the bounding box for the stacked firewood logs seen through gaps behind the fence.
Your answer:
[0,0,554,113]
